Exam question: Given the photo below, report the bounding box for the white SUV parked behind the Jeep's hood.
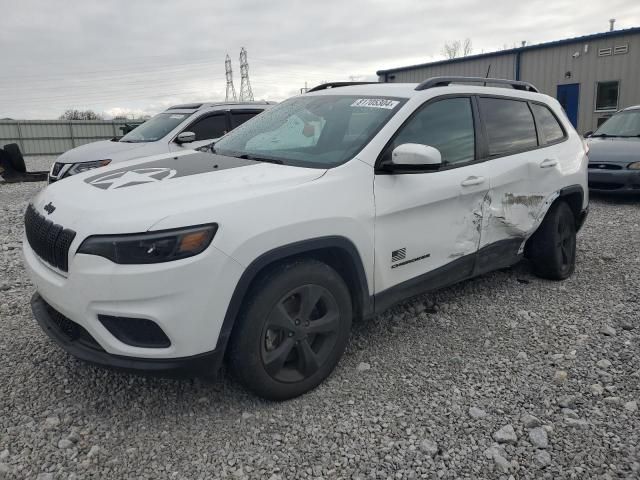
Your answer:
[49,102,273,183]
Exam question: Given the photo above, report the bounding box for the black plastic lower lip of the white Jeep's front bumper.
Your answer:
[31,292,224,375]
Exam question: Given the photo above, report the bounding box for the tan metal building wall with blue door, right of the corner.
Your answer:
[520,34,640,132]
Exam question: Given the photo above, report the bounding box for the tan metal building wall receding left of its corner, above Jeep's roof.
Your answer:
[379,54,515,83]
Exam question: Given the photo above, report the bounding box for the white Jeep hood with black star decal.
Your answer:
[33,152,326,239]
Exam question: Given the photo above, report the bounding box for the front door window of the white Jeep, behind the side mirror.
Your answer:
[388,98,475,165]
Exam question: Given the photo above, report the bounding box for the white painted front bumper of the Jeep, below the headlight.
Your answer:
[23,236,242,364]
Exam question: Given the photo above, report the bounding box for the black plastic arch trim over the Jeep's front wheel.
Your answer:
[216,236,373,351]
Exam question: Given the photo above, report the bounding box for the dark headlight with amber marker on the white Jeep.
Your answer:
[78,223,218,265]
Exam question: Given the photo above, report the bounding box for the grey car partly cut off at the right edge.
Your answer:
[585,105,640,193]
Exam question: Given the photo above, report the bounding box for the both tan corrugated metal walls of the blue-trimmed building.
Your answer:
[379,32,640,133]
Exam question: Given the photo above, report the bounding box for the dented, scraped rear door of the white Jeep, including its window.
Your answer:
[476,96,545,273]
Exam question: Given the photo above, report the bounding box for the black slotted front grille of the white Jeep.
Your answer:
[24,204,76,272]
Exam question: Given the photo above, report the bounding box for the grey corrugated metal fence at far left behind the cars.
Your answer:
[0,120,126,156]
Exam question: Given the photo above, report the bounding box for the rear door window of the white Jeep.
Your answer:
[478,97,538,156]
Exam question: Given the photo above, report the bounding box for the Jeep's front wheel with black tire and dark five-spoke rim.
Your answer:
[228,260,353,400]
